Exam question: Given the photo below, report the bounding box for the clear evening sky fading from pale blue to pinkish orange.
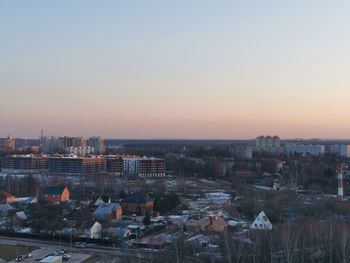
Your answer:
[0,0,350,139]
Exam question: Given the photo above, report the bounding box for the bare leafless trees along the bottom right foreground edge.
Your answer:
[154,221,350,263]
